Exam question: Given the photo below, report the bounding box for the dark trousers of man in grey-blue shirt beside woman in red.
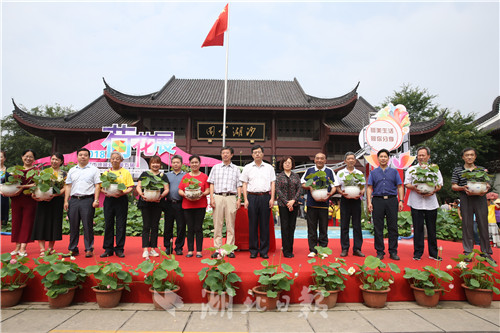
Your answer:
[163,201,186,252]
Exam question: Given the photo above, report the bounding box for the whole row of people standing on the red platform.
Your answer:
[0,145,492,260]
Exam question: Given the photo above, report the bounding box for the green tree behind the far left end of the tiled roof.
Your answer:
[0,104,75,166]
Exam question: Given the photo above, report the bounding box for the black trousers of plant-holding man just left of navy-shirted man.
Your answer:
[340,197,363,251]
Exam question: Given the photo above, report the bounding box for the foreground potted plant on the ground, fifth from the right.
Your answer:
[252,257,298,311]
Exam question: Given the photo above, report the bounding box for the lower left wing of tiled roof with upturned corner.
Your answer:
[13,95,136,130]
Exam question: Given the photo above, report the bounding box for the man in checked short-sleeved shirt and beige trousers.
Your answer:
[207,147,241,258]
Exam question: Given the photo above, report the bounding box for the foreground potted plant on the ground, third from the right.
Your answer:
[355,256,401,308]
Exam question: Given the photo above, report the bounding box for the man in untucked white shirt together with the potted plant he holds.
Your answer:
[404,147,443,261]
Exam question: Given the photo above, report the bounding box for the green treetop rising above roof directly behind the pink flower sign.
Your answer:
[375,83,447,122]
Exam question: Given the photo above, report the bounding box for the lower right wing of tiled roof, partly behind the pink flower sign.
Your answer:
[325,96,444,135]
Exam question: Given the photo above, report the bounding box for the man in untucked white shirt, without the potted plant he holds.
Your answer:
[404,147,443,261]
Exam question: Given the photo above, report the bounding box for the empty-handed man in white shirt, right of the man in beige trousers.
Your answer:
[240,145,276,259]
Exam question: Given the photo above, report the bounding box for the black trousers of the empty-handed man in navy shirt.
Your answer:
[372,197,399,255]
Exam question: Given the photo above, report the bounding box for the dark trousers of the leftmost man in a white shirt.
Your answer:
[68,196,95,252]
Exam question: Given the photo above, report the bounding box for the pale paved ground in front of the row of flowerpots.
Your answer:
[1,301,500,332]
